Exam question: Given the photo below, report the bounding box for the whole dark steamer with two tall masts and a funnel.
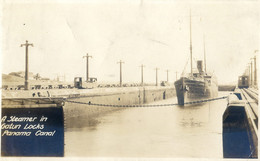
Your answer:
[174,11,218,105]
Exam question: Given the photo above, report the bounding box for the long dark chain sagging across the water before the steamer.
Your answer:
[65,96,227,107]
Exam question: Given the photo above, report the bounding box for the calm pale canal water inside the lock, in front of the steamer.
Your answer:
[65,92,228,158]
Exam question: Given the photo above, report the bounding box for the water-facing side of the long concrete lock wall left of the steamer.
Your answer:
[64,87,175,128]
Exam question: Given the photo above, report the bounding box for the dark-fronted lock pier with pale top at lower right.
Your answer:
[223,88,258,158]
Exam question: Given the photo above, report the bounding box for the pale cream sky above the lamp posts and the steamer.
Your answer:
[1,0,259,84]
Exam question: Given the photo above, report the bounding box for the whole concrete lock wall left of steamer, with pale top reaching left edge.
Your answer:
[2,86,175,128]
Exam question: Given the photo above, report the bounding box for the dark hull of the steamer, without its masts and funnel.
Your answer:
[174,77,218,105]
